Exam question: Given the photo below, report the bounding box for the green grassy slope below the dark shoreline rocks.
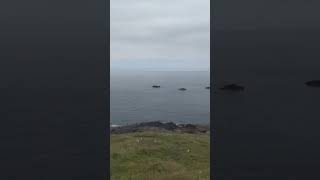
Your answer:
[110,132,210,180]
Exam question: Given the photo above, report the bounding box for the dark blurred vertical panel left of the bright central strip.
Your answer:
[0,0,109,180]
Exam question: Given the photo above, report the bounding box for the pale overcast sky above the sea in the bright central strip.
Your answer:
[110,0,210,71]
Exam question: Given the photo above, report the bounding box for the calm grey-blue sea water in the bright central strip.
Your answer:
[110,71,210,125]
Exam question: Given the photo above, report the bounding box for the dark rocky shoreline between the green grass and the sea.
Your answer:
[110,121,210,134]
